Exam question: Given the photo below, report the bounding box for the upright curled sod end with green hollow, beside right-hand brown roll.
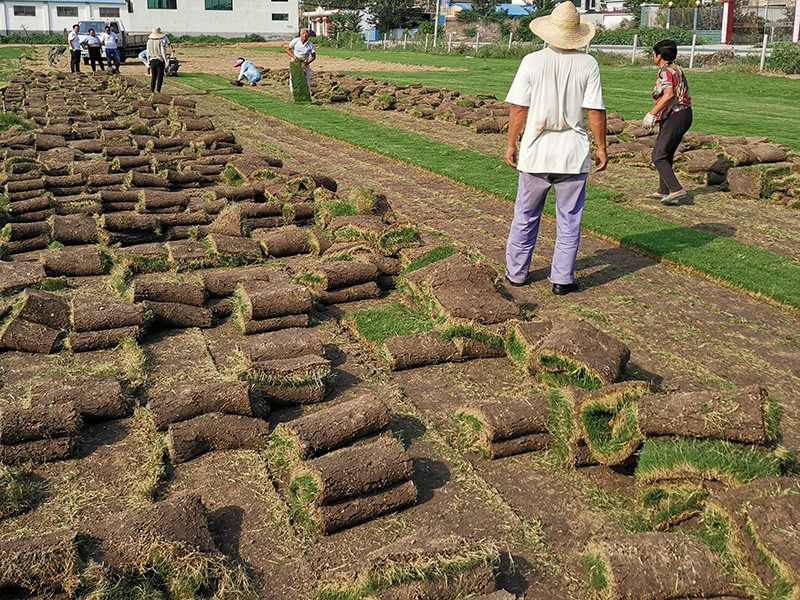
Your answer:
[578,381,650,465]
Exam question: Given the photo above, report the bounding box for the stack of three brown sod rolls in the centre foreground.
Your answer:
[267,395,417,535]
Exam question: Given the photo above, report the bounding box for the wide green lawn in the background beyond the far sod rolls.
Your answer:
[254,48,800,150]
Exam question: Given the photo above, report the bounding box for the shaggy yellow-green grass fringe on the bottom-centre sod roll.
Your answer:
[316,537,500,600]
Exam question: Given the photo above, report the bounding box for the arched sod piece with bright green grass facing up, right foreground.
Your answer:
[635,438,782,485]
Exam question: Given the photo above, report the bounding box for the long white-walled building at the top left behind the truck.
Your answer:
[0,0,298,40]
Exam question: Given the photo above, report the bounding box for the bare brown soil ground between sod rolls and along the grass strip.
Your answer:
[0,48,800,600]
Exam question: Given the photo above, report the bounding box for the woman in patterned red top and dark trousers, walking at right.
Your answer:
[642,40,692,205]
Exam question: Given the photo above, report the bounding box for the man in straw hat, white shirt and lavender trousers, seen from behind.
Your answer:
[505,2,608,295]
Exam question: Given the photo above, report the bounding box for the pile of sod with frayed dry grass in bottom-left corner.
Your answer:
[0,494,252,597]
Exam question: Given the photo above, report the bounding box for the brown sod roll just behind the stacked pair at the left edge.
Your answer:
[31,375,130,421]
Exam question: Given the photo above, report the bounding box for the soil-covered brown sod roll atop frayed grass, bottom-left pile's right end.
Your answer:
[79,494,218,574]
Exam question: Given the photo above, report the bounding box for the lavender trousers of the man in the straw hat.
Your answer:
[506,171,588,284]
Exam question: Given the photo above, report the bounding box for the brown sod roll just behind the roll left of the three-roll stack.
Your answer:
[147,382,255,429]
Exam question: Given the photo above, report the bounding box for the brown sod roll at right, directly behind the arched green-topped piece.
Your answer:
[637,385,770,444]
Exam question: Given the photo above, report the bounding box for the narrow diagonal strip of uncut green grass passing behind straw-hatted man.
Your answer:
[181,74,800,307]
